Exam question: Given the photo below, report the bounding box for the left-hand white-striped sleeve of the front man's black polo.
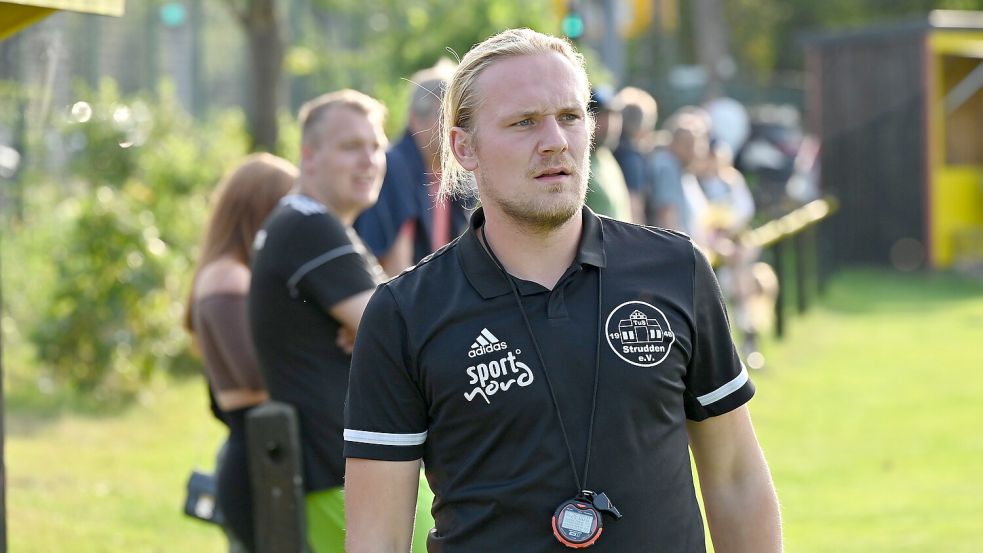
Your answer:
[345,286,427,461]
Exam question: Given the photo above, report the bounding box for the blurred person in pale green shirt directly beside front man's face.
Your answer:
[584,88,632,222]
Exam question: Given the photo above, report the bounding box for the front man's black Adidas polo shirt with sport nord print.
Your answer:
[345,208,754,553]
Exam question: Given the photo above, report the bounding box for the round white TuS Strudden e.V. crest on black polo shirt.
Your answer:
[605,301,676,367]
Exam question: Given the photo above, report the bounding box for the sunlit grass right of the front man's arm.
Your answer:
[751,271,983,553]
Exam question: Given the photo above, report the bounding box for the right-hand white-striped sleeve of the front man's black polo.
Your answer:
[685,248,754,421]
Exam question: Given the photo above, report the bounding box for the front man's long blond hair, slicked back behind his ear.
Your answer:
[440,29,590,198]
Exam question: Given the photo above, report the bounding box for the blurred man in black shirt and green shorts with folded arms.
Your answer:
[249,90,432,553]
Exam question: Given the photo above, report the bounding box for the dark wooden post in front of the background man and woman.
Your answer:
[246,401,308,553]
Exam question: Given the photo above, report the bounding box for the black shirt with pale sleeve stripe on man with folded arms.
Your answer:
[249,194,382,491]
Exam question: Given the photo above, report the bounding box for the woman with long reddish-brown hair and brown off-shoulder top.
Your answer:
[184,154,297,552]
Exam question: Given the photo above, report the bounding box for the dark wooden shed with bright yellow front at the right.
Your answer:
[805,11,983,269]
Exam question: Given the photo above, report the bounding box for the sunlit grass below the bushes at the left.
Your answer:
[6,381,223,553]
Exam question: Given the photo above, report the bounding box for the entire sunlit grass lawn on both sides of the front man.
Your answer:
[6,270,983,553]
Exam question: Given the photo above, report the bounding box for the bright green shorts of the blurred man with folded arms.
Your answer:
[305,472,433,553]
